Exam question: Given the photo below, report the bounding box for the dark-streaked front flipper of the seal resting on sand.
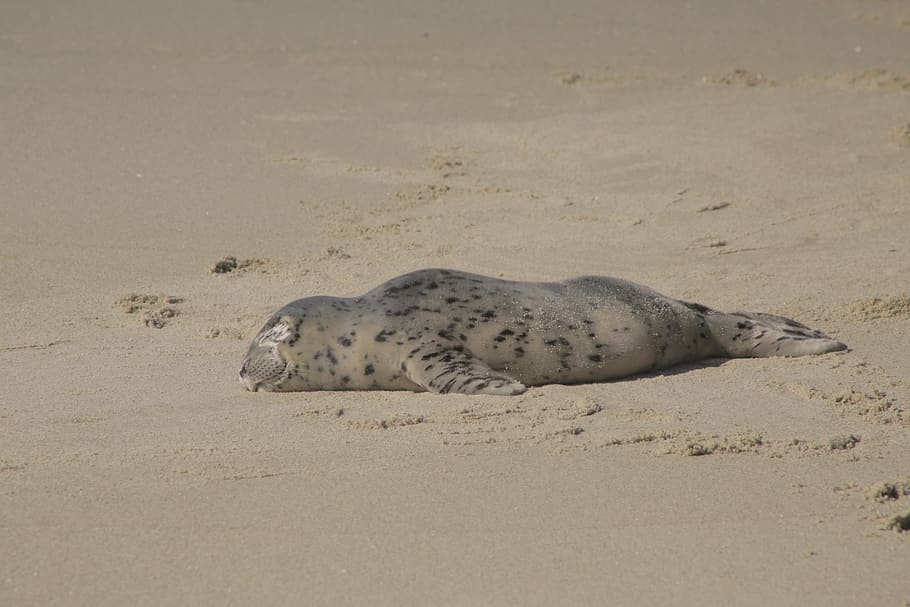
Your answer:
[402,342,527,396]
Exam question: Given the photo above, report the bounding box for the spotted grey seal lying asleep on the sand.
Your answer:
[240,269,847,395]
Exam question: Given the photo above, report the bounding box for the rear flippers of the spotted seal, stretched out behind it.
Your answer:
[705,310,847,358]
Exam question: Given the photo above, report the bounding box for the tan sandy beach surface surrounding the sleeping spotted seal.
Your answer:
[0,0,910,606]
